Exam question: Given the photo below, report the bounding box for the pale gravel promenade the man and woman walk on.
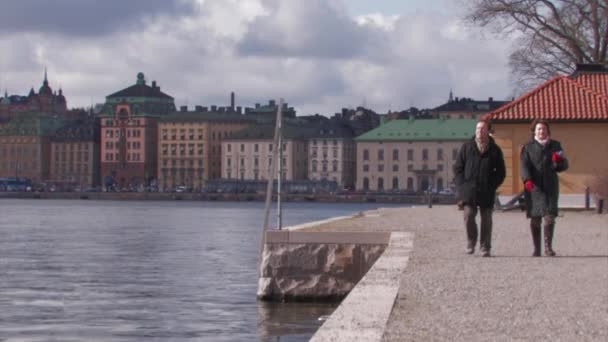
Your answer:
[307,206,608,341]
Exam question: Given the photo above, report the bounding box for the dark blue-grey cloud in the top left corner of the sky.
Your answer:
[0,0,194,36]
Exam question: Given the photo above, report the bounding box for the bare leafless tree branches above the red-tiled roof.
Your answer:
[465,0,608,90]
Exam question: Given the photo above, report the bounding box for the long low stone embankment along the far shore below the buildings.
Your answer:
[0,192,456,205]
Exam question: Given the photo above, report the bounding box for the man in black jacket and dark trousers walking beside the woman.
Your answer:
[454,120,506,257]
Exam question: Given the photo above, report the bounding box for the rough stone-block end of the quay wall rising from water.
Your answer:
[257,230,390,301]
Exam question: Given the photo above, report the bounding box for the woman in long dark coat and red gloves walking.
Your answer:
[520,120,568,256]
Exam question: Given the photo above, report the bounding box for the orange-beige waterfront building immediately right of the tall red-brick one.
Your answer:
[158,112,254,191]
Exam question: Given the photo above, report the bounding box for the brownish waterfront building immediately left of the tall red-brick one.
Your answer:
[46,118,100,190]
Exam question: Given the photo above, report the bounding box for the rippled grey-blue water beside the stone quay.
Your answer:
[0,200,406,341]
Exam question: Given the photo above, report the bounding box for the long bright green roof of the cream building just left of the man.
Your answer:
[355,119,477,141]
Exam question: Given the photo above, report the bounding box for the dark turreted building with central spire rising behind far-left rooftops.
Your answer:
[0,70,68,121]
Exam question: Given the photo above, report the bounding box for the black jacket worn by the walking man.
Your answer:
[454,137,506,208]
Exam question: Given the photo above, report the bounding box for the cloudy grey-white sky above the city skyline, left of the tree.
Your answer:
[0,0,512,115]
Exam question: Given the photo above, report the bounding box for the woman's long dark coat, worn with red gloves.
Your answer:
[520,139,568,217]
